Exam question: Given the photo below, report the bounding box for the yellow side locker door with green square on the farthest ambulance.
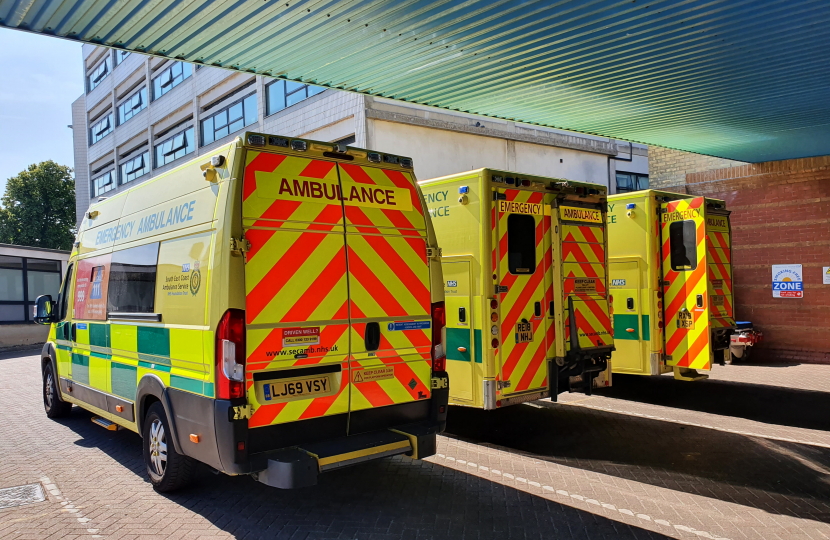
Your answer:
[609,259,649,374]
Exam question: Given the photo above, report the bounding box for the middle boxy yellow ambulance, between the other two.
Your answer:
[421,169,614,409]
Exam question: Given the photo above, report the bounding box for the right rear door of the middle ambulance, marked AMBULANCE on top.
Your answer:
[557,200,614,352]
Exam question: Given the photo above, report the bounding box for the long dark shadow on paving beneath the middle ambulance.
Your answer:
[447,402,830,522]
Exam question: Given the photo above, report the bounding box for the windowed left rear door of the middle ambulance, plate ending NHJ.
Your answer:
[493,189,548,397]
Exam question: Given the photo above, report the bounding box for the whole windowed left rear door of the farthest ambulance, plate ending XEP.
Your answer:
[660,197,712,369]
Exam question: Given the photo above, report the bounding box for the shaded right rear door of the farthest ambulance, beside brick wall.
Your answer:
[706,208,735,328]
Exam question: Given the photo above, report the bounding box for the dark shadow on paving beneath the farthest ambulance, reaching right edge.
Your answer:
[596,375,830,431]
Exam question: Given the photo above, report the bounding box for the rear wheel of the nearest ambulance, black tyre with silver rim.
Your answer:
[142,401,196,493]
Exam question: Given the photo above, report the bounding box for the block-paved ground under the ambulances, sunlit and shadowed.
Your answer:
[0,353,830,540]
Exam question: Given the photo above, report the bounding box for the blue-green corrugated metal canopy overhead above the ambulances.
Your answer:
[0,0,830,161]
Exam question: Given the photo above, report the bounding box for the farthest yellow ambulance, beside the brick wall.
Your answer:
[608,190,735,380]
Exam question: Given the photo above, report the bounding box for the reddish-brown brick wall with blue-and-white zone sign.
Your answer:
[684,158,830,363]
